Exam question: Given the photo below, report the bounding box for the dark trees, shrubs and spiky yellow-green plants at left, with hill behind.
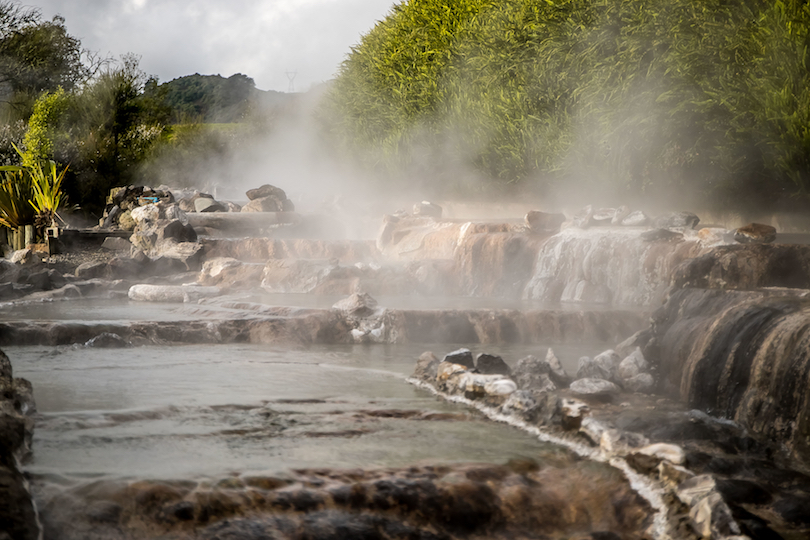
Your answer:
[0,0,287,227]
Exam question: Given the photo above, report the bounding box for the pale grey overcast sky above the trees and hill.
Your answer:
[30,0,395,91]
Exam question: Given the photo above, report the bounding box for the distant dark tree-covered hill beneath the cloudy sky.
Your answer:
[159,73,292,123]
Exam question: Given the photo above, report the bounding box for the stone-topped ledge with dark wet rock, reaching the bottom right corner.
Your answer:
[412,346,810,540]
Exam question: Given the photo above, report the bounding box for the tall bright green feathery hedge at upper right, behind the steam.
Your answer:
[331,0,810,210]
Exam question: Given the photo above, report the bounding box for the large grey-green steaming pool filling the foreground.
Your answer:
[6,345,598,484]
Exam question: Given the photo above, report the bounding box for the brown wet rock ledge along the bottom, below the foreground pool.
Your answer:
[38,455,651,540]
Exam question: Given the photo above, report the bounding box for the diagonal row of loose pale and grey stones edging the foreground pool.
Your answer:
[413,346,777,540]
